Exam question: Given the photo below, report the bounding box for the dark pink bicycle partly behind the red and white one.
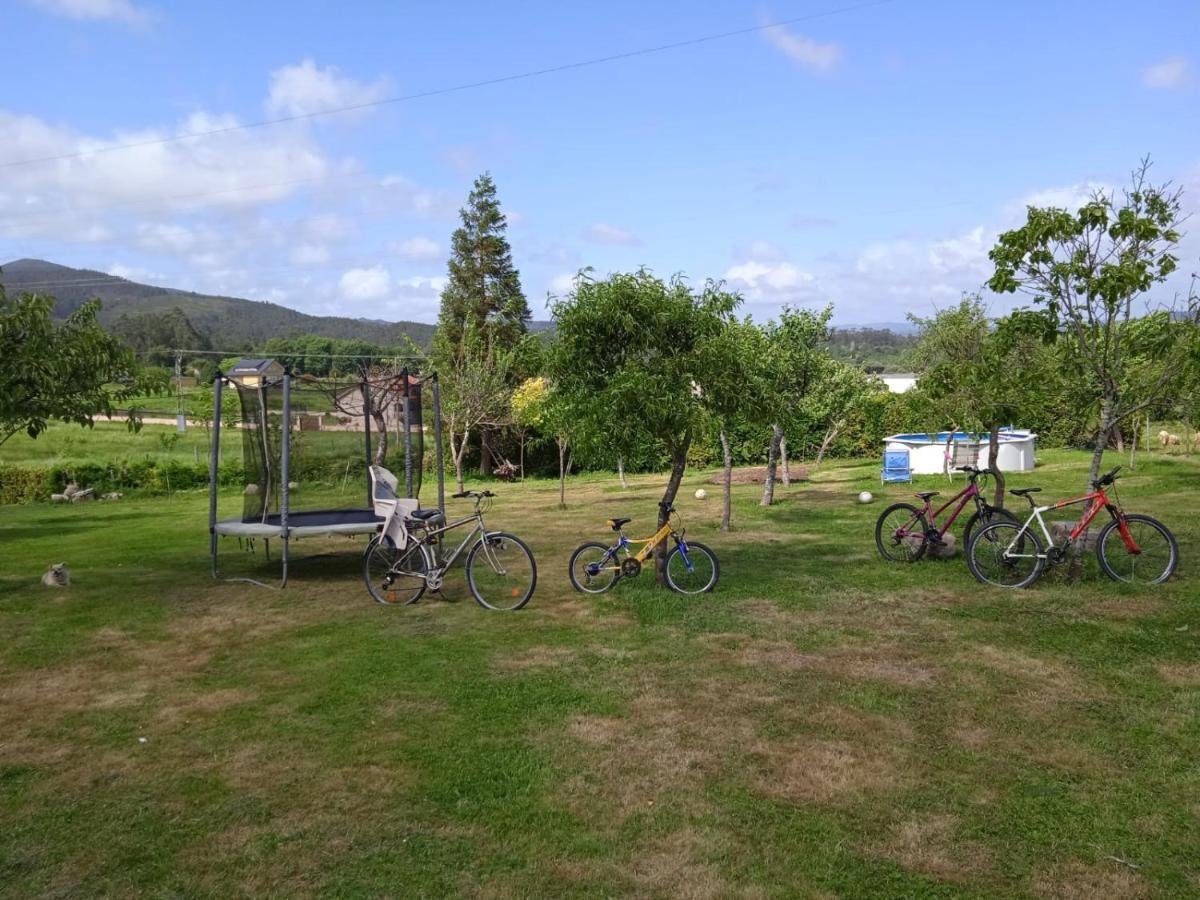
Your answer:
[875,466,1016,563]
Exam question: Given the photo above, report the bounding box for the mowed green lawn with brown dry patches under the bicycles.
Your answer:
[0,451,1200,898]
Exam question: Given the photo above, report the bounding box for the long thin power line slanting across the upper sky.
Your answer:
[0,0,894,169]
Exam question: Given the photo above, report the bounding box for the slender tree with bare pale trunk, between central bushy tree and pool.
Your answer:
[761,306,833,506]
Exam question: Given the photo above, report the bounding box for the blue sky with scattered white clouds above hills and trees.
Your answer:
[0,0,1200,325]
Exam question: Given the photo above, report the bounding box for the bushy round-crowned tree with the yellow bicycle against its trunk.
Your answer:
[548,269,740,583]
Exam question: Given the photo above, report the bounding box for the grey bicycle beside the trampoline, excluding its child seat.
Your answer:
[362,491,538,610]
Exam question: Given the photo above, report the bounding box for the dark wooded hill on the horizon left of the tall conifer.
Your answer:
[0,259,433,349]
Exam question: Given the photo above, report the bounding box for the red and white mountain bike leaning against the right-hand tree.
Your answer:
[967,466,1180,588]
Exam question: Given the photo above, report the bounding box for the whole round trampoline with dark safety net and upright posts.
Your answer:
[209,360,445,587]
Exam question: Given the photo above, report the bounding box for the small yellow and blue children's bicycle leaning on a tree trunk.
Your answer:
[569,504,720,594]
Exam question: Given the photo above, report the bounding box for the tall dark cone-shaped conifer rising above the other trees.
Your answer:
[433,172,530,365]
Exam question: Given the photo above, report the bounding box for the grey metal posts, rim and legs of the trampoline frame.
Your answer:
[209,368,445,588]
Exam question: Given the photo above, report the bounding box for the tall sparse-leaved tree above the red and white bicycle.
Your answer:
[988,160,1196,481]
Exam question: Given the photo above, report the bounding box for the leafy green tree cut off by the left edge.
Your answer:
[0,286,153,444]
